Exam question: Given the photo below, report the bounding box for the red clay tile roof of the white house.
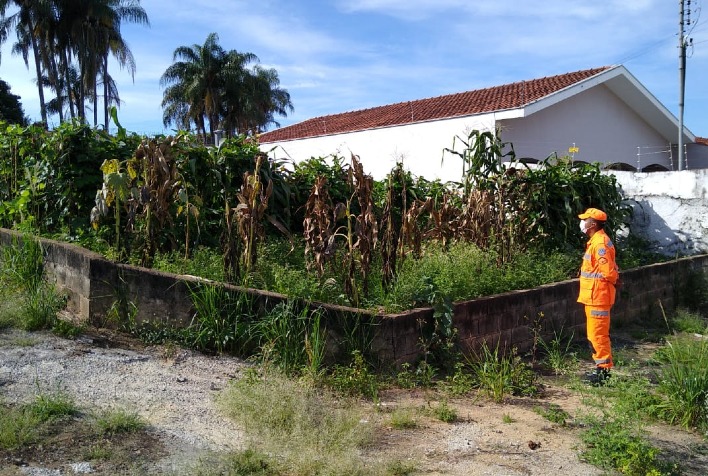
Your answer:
[259,66,610,143]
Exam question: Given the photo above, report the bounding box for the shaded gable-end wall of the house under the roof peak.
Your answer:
[501,85,673,170]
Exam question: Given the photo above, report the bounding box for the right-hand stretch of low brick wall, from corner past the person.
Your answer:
[366,255,708,364]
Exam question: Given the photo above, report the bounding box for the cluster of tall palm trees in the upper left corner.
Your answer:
[0,0,149,126]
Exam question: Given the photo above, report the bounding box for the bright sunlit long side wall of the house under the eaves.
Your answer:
[261,114,494,182]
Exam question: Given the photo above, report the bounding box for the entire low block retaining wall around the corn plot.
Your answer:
[0,229,708,364]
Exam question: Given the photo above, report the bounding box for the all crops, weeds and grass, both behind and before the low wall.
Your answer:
[0,119,708,474]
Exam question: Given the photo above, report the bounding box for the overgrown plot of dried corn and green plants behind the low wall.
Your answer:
[0,117,644,309]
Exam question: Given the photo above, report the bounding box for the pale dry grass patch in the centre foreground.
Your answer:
[219,372,383,475]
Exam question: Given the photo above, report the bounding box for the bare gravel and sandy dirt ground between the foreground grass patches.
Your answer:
[0,331,708,476]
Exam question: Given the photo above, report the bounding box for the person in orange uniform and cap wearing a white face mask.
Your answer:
[578,208,619,384]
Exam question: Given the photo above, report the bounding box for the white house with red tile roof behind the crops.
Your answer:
[260,65,708,180]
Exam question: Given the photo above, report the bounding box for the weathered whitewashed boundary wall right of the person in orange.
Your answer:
[611,169,708,255]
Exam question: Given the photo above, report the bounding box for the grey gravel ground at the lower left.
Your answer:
[0,330,247,474]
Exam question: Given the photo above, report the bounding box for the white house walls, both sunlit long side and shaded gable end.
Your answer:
[261,85,696,181]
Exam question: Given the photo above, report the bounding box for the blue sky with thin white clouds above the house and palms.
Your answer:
[0,0,708,137]
